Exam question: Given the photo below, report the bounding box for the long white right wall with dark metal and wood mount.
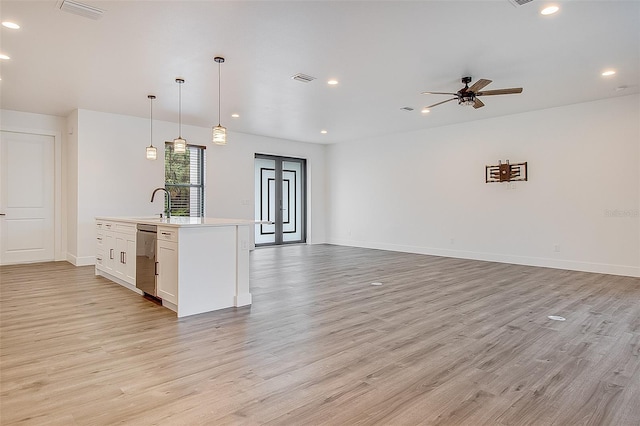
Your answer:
[326,95,640,276]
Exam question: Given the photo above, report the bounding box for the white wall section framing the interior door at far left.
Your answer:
[0,110,67,260]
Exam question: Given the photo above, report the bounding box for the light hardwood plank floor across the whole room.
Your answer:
[0,245,640,426]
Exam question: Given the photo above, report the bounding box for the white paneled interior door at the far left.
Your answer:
[0,131,55,265]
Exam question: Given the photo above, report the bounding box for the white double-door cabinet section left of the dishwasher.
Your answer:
[96,220,136,286]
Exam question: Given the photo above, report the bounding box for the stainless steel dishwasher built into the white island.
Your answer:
[136,223,158,297]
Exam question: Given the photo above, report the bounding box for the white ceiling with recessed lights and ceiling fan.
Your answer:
[0,0,640,143]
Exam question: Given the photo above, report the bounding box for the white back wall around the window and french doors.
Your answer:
[70,110,325,265]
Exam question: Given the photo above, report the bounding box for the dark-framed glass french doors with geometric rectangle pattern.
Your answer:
[255,154,307,246]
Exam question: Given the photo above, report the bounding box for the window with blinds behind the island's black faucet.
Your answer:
[164,142,205,217]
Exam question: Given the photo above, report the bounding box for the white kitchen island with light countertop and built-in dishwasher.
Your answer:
[95,217,255,317]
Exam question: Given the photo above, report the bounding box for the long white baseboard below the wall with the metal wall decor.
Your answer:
[328,239,640,277]
